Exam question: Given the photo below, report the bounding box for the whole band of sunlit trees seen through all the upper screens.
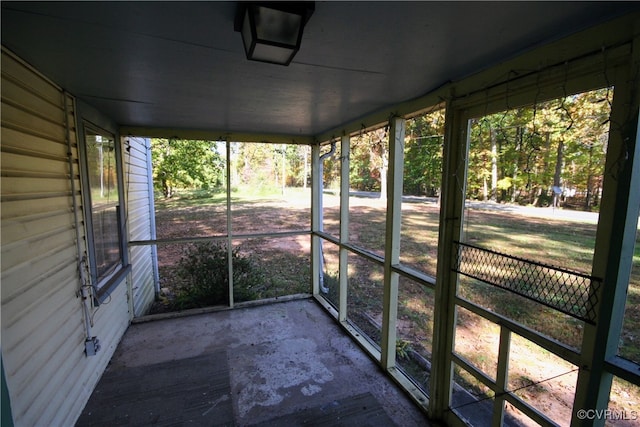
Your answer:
[152,88,613,210]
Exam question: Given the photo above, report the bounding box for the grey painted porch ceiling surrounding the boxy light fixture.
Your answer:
[2,1,639,136]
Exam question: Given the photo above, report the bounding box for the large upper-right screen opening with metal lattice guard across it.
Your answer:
[459,88,613,348]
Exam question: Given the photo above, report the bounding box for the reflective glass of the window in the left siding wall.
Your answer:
[86,128,121,283]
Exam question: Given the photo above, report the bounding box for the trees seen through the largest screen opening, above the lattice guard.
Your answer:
[467,88,613,210]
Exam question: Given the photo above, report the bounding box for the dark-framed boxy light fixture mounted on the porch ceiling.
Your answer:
[234,2,315,65]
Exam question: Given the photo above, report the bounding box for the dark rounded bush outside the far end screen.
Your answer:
[175,242,265,310]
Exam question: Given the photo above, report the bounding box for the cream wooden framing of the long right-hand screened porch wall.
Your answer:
[313,20,640,426]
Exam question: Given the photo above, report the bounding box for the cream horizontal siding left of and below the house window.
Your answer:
[0,49,130,426]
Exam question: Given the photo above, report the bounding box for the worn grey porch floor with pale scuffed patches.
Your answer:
[78,299,430,427]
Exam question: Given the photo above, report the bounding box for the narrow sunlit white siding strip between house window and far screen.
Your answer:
[125,137,156,316]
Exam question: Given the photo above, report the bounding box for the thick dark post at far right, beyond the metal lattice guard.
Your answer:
[571,37,640,426]
